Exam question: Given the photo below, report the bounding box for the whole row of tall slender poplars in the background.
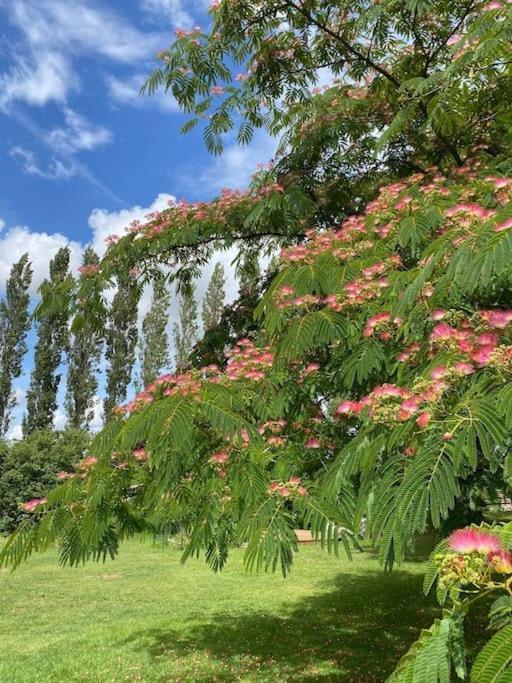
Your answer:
[0,247,260,438]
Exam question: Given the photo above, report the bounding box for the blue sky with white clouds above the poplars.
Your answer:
[0,0,274,438]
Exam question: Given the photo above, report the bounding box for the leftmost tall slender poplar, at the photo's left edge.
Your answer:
[0,254,32,436]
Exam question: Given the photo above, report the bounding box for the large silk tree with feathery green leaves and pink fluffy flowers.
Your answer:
[2,0,512,683]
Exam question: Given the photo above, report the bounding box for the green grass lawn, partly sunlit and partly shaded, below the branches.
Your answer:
[0,541,488,683]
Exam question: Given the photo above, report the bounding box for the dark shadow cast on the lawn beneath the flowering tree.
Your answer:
[118,571,454,683]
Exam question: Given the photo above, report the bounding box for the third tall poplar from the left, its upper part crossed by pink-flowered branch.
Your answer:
[66,248,102,429]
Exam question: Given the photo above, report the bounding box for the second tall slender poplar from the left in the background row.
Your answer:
[23,247,73,435]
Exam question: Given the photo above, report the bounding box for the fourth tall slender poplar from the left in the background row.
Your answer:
[104,275,140,420]
